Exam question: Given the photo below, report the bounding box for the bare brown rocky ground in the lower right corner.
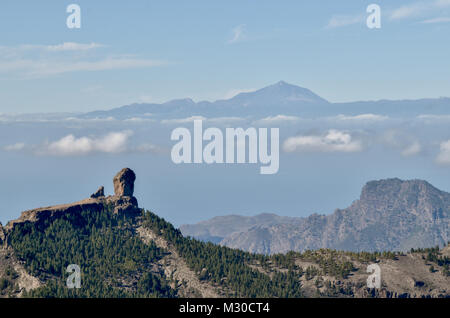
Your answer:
[250,246,450,298]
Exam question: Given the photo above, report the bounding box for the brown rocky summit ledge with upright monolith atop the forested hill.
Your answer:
[4,168,141,231]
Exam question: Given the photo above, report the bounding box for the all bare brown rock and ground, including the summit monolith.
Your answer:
[0,169,450,298]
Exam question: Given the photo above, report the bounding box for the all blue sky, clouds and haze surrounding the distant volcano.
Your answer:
[0,0,450,225]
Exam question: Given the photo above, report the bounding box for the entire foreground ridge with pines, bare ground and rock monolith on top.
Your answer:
[0,168,450,298]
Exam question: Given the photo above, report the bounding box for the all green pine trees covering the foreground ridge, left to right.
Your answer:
[5,206,450,297]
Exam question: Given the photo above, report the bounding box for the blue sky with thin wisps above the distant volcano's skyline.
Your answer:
[0,0,450,113]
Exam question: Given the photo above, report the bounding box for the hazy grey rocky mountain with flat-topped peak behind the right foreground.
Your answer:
[181,179,450,254]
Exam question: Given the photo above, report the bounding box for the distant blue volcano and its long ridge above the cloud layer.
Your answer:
[79,81,450,119]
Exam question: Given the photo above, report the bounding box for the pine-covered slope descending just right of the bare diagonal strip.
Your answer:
[144,212,302,297]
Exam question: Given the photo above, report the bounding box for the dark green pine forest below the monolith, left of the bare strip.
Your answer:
[9,207,176,297]
